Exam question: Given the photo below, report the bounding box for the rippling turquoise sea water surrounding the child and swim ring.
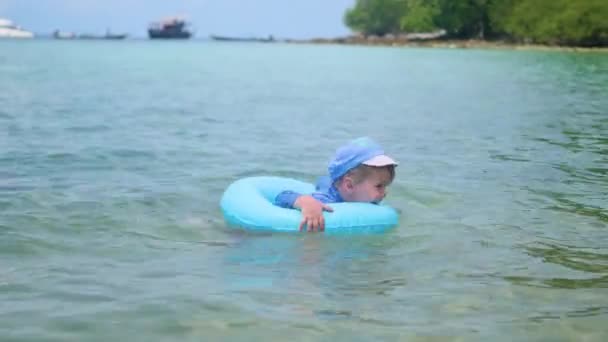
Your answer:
[0,40,608,341]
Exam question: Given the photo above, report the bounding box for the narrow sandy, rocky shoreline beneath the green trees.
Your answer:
[285,37,608,52]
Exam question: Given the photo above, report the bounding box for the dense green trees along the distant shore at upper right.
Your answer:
[344,0,608,46]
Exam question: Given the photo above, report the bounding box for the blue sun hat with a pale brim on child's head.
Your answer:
[327,137,399,183]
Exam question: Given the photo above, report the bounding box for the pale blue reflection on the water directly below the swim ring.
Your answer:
[216,233,407,320]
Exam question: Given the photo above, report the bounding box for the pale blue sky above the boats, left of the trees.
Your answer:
[0,0,355,39]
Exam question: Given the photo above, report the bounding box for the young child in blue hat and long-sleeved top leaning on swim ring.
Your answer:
[275,137,398,231]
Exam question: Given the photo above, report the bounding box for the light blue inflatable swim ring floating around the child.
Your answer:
[220,177,399,234]
